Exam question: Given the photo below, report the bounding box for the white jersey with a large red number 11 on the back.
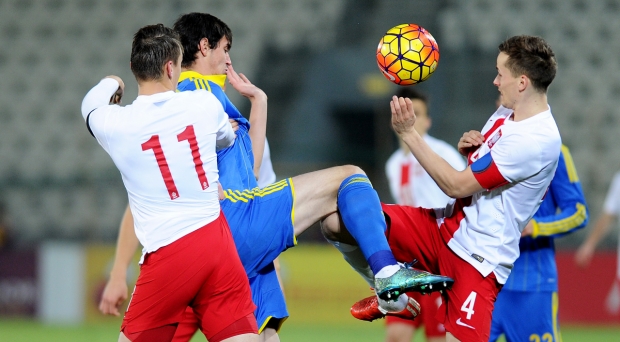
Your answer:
[82,79,234,253]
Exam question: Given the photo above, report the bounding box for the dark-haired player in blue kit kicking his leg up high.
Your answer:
[102,18,452,340]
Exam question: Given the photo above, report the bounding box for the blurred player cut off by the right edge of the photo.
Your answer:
[575,172,620,314]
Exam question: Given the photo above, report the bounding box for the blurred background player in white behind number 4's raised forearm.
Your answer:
[385,87,467,342]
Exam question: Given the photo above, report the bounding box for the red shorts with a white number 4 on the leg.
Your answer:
[382,202,501,341]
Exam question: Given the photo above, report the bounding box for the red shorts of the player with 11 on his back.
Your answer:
[121,214,257,339]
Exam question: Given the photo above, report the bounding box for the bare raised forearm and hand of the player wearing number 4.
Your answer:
[390,96,484,198]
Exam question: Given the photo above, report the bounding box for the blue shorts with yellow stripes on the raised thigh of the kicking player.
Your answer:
[220,178,297,278]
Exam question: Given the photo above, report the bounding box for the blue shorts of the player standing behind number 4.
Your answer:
[489,290,560,342]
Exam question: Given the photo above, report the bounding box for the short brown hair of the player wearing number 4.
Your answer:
[499,36,558,93]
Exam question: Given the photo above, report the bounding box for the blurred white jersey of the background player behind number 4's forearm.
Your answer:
[385,134,467,208]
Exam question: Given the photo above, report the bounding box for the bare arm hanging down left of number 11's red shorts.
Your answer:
[99,206,139,316]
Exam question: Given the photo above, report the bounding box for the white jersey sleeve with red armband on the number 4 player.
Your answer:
[471,134,542,190]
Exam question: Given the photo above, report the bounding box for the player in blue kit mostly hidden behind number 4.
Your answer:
[490,146,588,341]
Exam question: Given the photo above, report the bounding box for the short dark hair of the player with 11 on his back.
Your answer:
[131,24,183,81]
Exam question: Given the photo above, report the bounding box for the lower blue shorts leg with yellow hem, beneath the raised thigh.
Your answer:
[250,263,288,334]
